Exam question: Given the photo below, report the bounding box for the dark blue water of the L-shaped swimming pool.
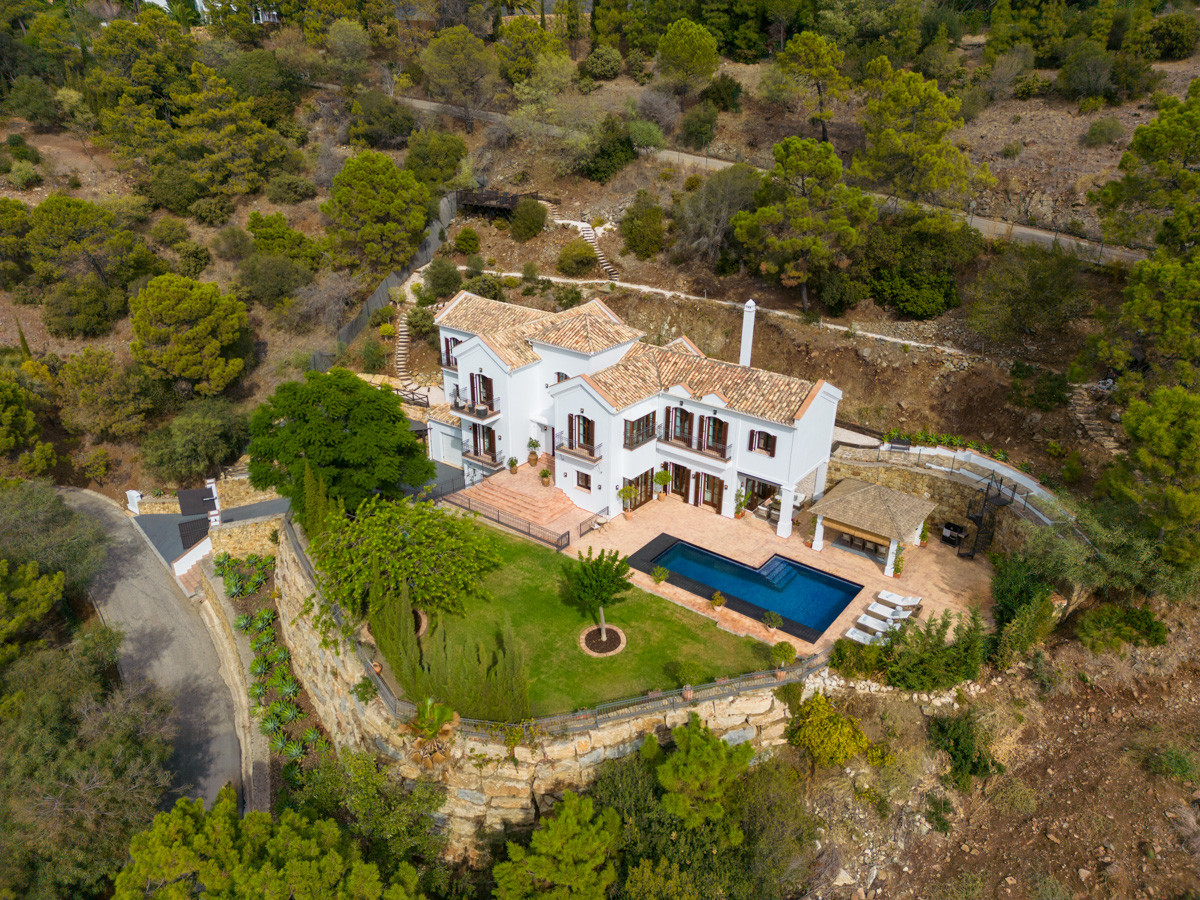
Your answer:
[654,541,863,632]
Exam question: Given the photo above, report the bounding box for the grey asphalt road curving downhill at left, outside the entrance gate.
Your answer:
[62,488,241,805]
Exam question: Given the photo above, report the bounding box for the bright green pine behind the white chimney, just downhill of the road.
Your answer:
[732,137,877,308]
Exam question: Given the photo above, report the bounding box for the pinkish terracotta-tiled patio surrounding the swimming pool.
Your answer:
[571,497,992,655]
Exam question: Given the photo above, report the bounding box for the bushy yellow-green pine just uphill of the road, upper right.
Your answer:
[851,56,991,200]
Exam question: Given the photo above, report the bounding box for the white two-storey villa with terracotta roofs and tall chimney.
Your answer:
[428,292,841,536]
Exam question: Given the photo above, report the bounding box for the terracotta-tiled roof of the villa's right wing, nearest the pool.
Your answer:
[586,343,812,425]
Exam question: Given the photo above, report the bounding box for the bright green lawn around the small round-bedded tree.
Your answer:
[427,532,770,715]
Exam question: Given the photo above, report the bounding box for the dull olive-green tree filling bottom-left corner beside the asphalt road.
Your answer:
[0,629,172,898]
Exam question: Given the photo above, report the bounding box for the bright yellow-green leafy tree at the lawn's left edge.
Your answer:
[312,496,499,618]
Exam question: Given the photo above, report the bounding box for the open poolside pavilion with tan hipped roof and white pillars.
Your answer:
[809,478,937,576]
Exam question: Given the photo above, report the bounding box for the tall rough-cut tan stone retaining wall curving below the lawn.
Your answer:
[275,520,787,858]
